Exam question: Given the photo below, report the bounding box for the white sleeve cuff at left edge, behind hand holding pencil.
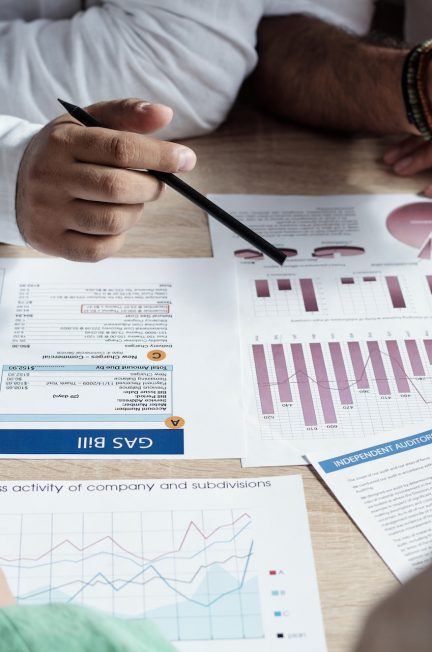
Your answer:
[0,115,41,246]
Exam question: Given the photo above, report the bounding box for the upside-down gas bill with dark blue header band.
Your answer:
[0,259,244,458]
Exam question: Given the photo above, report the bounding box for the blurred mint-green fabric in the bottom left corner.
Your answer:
[0,604,175,652]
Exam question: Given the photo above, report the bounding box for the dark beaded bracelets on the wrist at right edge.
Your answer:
[402,39,432,140]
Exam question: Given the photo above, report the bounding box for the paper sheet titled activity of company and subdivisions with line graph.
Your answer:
[0,476,326,652]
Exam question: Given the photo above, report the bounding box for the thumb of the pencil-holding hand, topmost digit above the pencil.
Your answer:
[82,98,173,134]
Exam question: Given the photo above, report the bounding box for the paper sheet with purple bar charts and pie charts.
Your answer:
[211,195,432,466]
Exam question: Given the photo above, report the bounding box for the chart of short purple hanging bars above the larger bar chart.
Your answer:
[250,272,422,319]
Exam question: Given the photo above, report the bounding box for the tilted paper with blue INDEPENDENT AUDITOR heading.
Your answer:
[308,427,432,582]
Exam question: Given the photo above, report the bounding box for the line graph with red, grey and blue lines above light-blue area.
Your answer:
[0,509,263,641]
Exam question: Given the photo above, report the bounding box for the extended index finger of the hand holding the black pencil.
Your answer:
[69,125,196,172]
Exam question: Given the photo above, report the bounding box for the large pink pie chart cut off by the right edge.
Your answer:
[387,202,432,260]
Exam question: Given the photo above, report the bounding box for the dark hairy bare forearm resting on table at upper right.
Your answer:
[253,15,417,134]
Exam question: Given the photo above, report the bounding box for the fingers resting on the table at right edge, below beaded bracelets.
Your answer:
[383,136,432,192]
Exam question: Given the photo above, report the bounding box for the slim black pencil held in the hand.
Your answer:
[59,99,286,265]
